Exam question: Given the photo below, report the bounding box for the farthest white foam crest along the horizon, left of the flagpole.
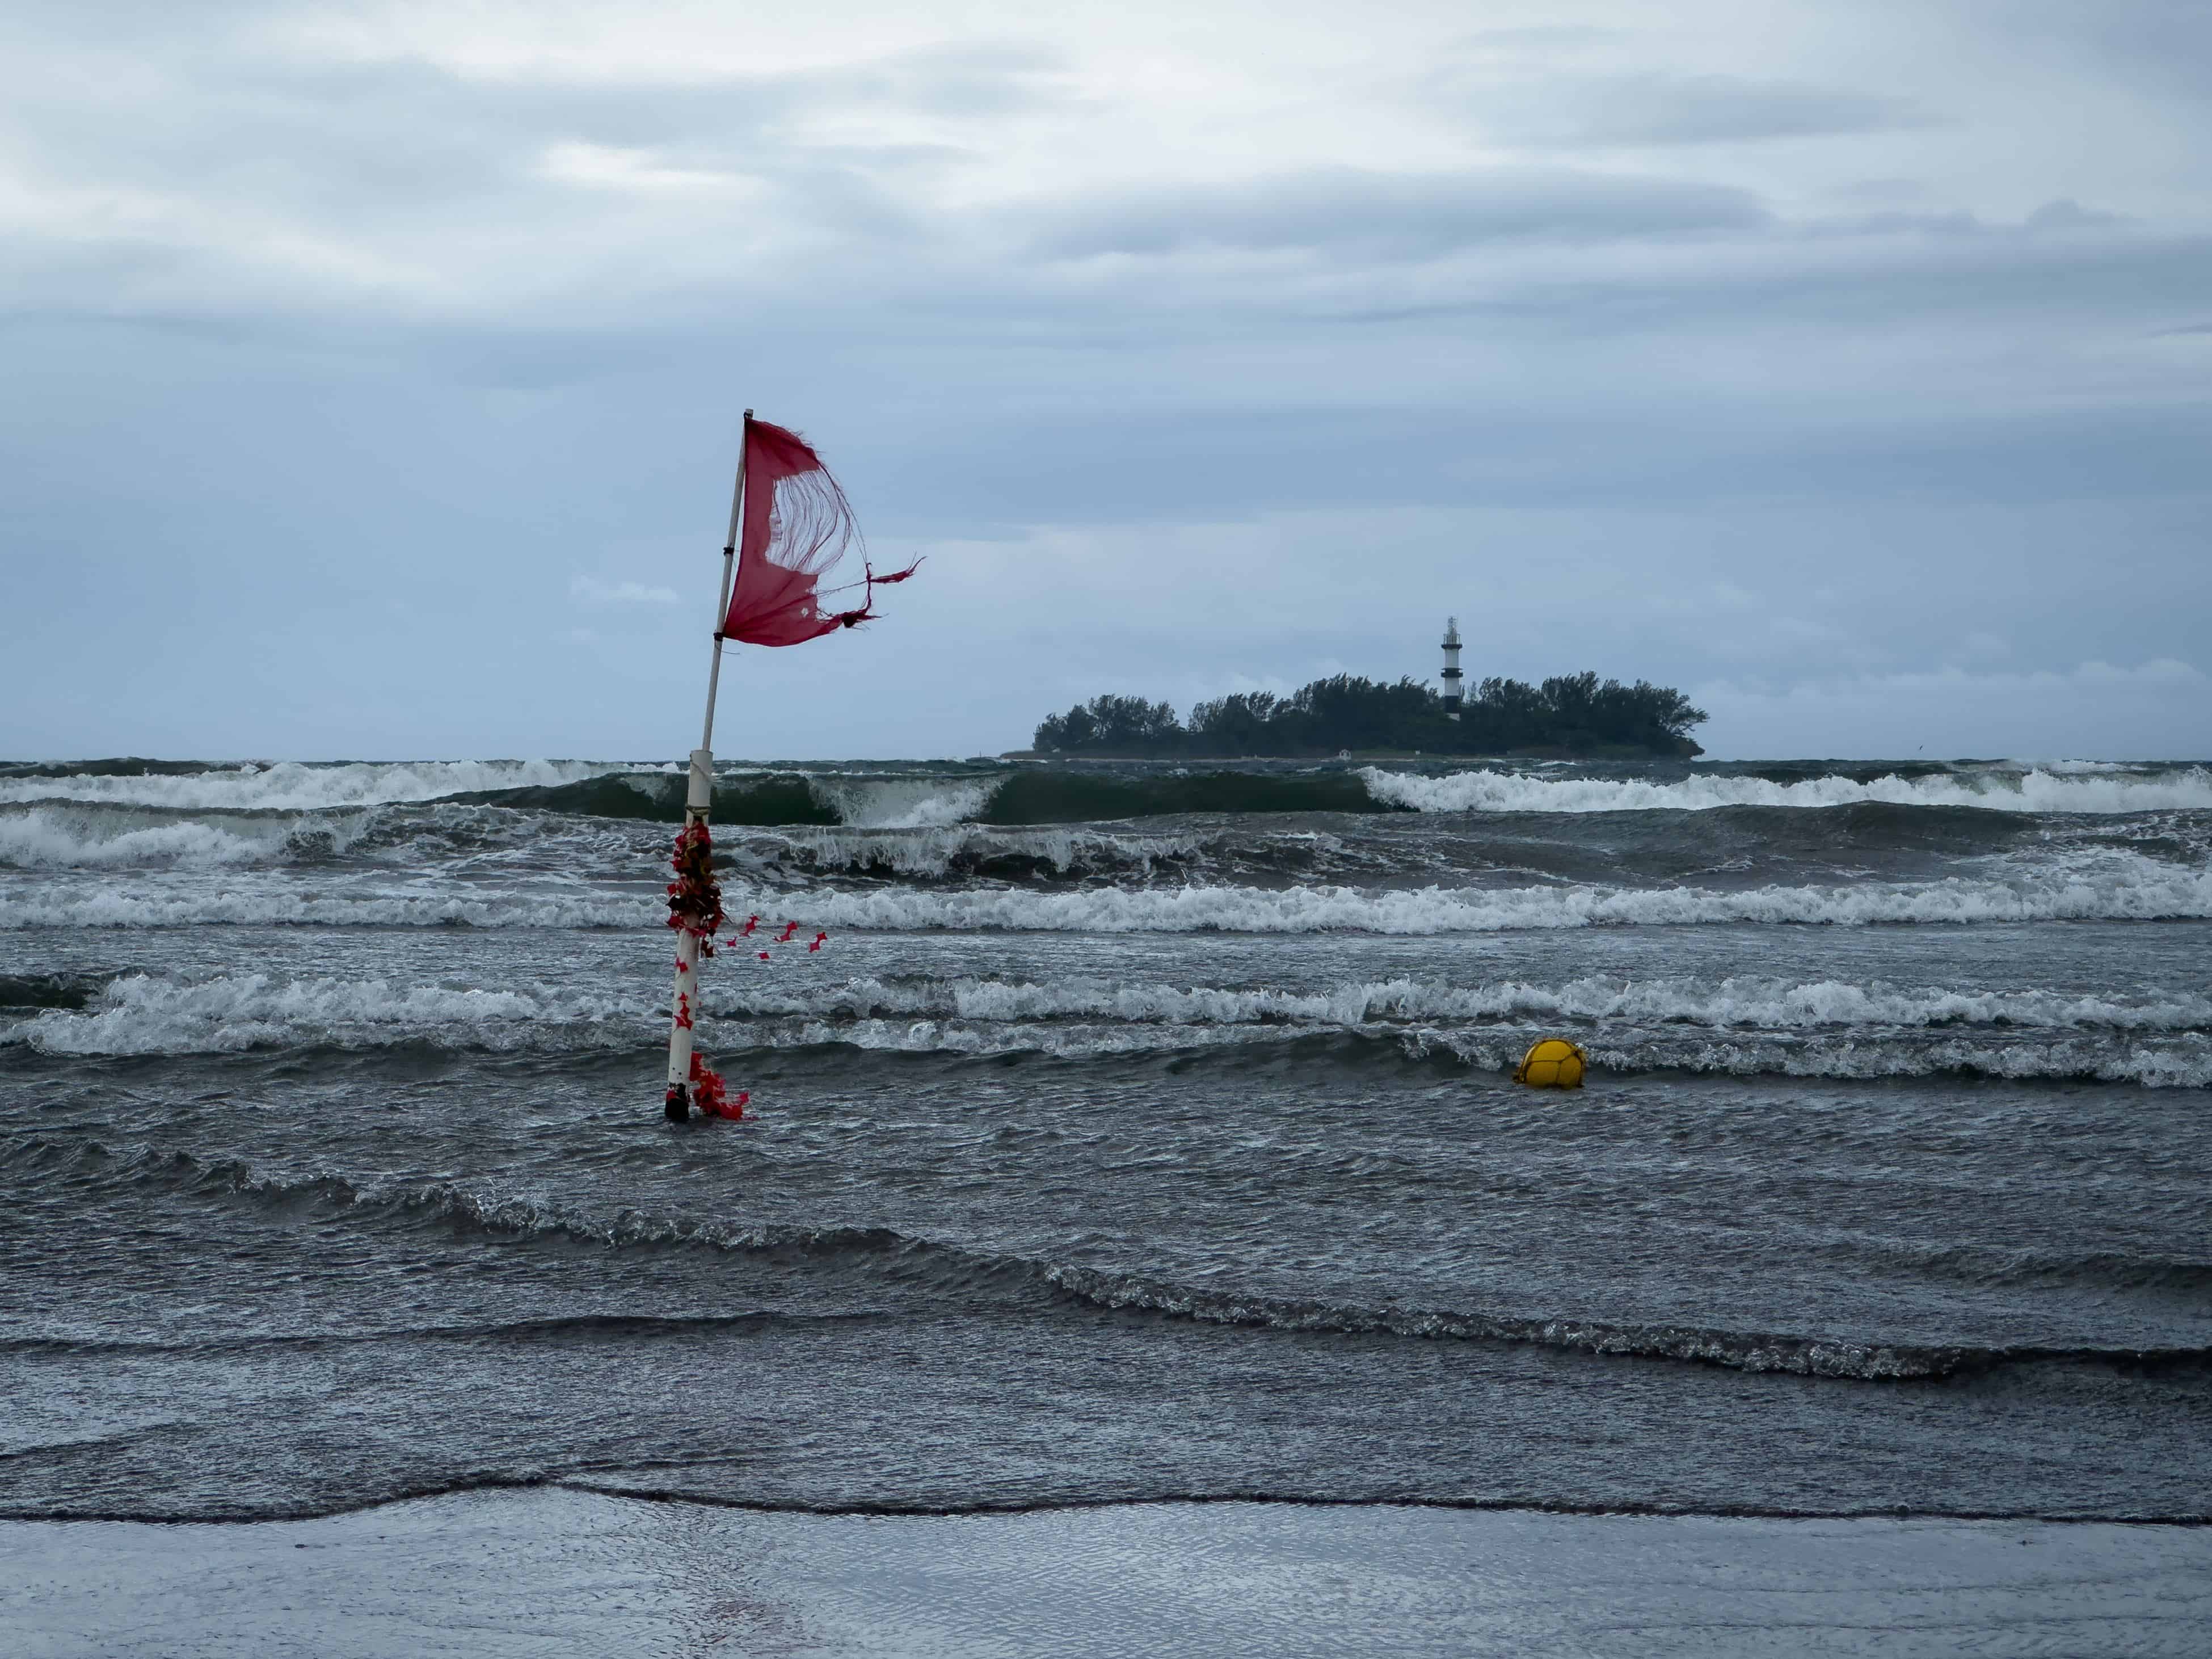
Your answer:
[0,761,635,812]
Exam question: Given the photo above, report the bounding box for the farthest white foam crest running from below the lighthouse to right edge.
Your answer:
[1360,765,2212,812]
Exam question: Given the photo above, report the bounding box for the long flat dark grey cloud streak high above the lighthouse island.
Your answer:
[1031,168,1767,259]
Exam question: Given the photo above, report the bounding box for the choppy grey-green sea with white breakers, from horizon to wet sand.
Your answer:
[0,761,2212,1519]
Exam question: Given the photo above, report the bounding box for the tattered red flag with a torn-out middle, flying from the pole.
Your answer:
[721,416,920,646]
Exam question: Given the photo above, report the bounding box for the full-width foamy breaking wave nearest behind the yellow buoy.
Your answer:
[12,973,2212,1088]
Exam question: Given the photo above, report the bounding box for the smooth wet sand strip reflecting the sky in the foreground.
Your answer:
[0,1487,2212,1659]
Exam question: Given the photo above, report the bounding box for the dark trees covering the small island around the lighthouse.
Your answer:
[1035,672,1705,759]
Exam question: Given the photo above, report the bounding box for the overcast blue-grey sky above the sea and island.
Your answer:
[0,0,2212,759]
